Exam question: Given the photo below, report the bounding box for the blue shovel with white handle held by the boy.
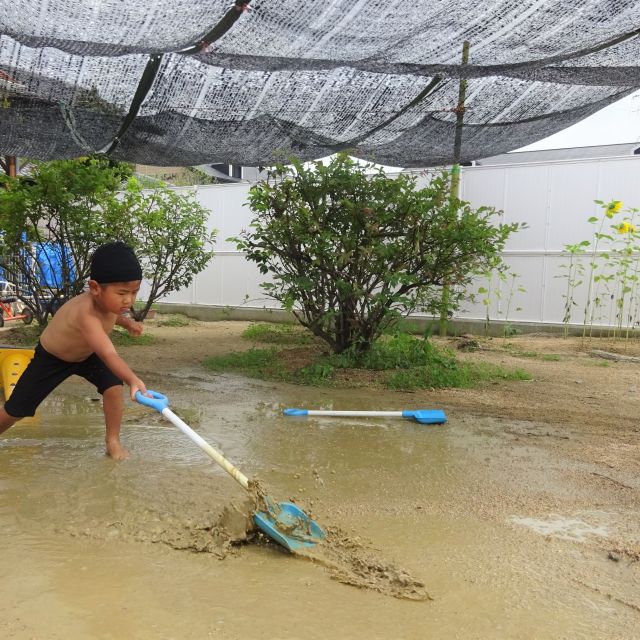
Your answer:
[136,391,326,551]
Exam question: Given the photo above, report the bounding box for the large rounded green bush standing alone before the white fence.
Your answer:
[235,154,519,353]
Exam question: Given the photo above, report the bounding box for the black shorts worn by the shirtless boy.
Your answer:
[4,342,122,418]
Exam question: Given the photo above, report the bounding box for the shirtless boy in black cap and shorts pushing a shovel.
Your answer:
[0,242,147,460]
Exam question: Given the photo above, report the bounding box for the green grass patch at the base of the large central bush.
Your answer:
[204,334,531,390]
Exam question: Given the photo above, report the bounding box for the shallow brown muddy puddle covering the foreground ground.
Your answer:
[0,372,640,640]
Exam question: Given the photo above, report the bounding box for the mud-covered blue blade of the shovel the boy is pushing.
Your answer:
[253,502,326,551]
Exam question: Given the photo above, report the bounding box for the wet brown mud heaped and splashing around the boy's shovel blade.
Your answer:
[51,458,431,601]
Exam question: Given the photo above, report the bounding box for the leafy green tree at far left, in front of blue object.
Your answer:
[0,158,131,325]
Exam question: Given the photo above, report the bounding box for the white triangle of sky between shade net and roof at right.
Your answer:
[518,91,640,151]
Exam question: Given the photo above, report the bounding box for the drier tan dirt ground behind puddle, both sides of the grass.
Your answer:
[130,316,640,440]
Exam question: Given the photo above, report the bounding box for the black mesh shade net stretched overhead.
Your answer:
[0,0,640,167]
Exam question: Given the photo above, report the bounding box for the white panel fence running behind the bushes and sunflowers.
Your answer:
[149,156,640,324]
